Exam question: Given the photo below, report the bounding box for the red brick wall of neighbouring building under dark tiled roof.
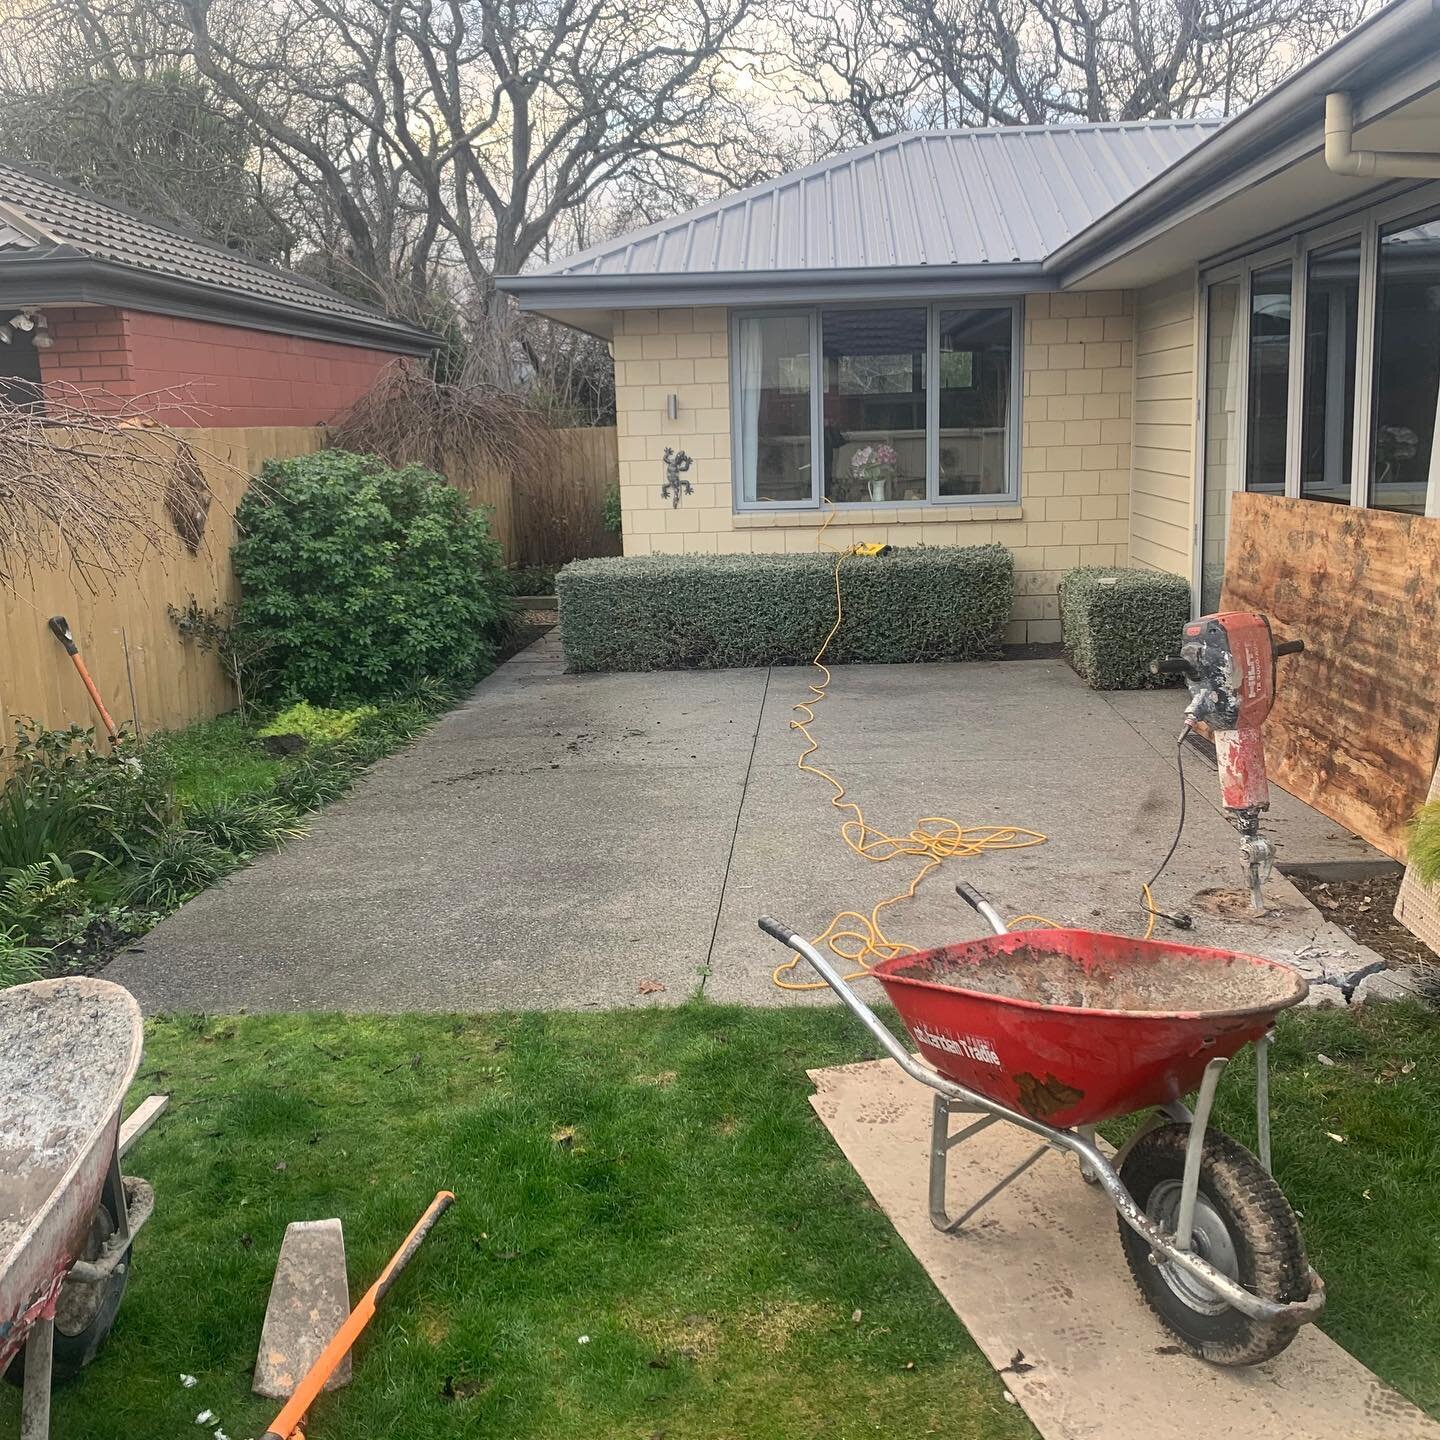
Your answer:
[40,307,406,425]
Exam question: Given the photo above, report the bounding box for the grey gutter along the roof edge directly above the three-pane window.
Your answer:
[495,261,1058,310]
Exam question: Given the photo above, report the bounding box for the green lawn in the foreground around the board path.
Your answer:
[0,1004,1440,1440]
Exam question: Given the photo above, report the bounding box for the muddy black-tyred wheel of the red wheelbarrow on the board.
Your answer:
[1119,1125,1310,1365]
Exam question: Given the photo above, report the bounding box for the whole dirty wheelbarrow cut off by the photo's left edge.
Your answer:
[0,976,156,1440]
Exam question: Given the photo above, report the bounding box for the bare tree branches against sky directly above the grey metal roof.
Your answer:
[796,0,1374,143]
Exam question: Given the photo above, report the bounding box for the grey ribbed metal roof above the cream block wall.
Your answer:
[537,120,1218,278]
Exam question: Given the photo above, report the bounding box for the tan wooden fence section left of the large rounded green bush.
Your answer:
[0,426,324,747]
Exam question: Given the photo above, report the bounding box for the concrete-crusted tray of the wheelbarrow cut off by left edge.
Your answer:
[0,976,144,1372]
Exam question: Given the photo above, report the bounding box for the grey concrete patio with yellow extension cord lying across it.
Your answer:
[108,635,1374,1011]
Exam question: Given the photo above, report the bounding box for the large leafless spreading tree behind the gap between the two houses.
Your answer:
[168,0,771,370]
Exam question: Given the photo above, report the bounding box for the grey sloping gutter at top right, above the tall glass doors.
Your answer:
[1044,0,1440,284]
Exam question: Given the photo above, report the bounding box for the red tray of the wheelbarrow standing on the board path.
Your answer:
[871,929,1308,1129]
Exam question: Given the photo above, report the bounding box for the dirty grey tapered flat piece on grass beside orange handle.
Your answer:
[252,1220,350,1400]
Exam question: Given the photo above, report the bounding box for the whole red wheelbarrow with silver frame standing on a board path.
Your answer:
[760,886,1325,1365]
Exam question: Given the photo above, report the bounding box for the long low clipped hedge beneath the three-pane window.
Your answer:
[556,544,1015,671]
